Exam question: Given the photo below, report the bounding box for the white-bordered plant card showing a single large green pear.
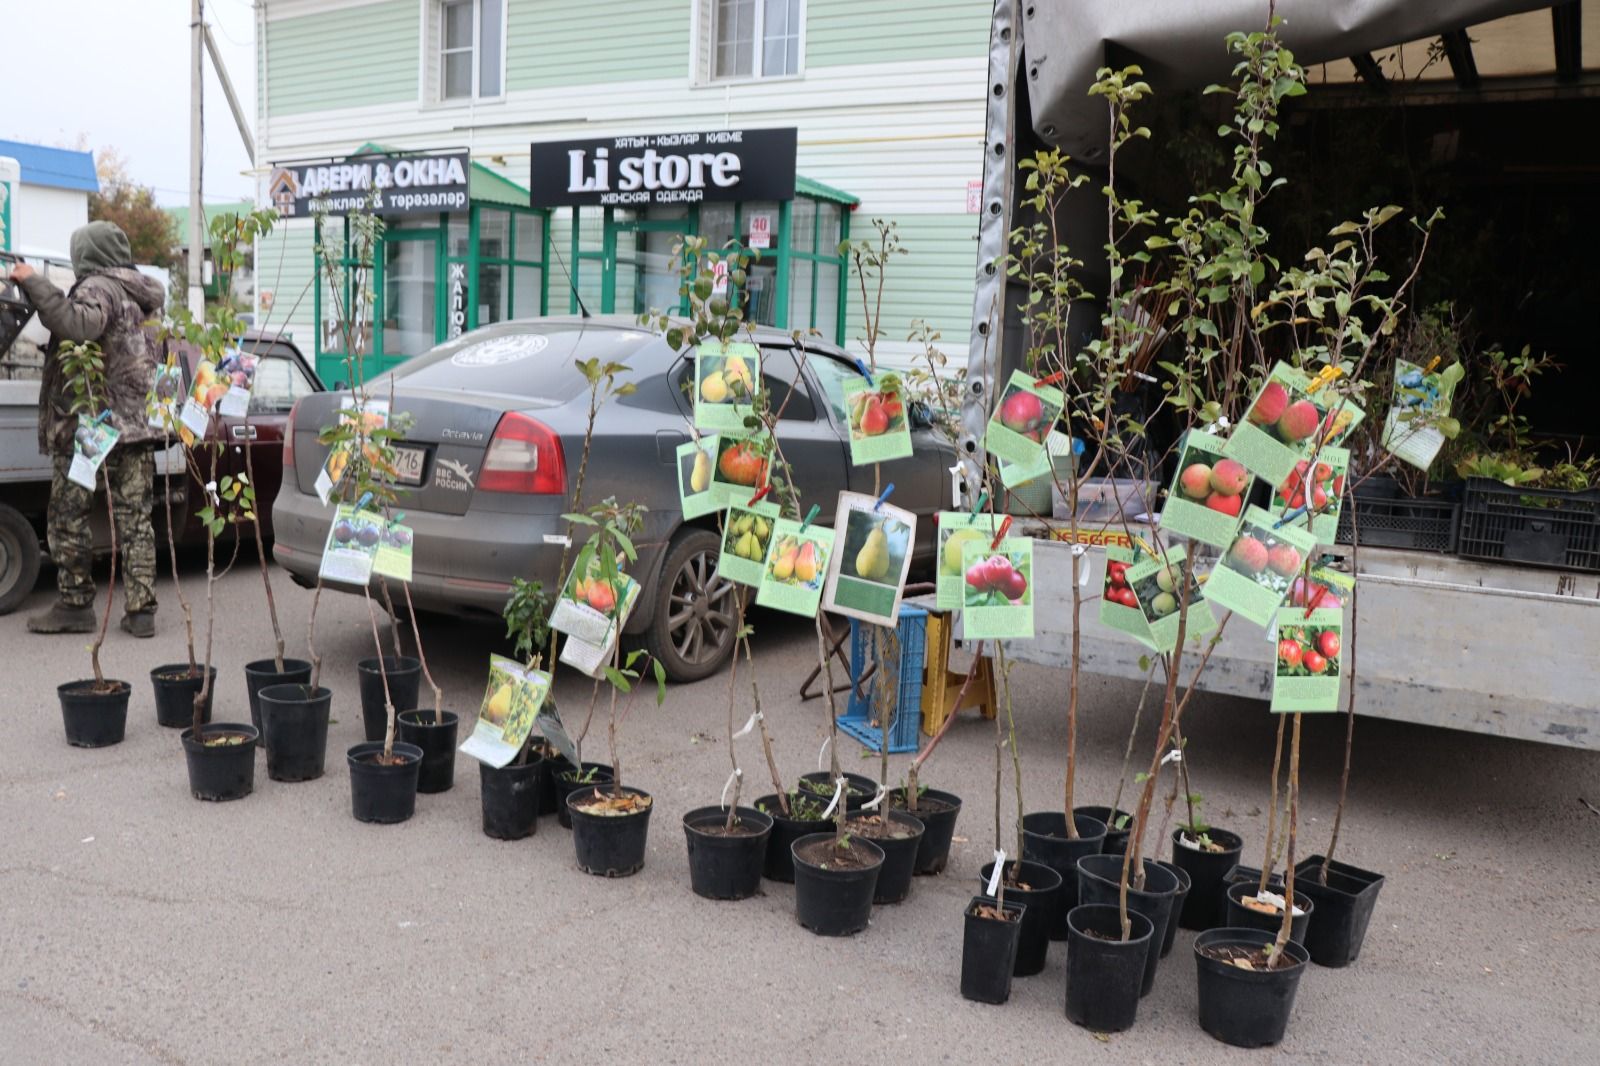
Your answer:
[822,491,917,626]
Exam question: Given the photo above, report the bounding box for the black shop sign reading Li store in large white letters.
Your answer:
[528,130,795,208]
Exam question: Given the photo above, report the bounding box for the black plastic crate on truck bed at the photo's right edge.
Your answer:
[1458,477,1600,573]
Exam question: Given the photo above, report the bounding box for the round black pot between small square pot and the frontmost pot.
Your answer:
[1067,903,1155,1032]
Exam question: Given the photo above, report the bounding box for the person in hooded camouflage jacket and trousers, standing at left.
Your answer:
[11,222,165,637]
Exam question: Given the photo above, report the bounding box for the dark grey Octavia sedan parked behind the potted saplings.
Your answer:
[272,315,954,680]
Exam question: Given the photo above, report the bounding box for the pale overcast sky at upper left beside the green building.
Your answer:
[0,0,256,205]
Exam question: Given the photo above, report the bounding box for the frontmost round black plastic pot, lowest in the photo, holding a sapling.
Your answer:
[1195,928,1309,1047]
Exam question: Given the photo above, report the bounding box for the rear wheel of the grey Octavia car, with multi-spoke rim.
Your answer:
[645,527,738,682]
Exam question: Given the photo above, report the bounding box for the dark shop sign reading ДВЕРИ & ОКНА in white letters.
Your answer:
[267,152,469,218]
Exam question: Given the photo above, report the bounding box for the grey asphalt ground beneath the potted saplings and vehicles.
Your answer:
[0,550,1600,1066]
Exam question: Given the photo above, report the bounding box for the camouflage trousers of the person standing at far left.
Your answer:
[46,448,155,615]
